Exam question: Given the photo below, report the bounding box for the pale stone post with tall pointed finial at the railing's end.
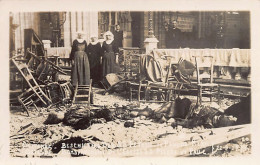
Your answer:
[144,11,159,54]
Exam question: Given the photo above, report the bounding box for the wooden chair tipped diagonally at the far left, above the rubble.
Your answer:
[11,57,52,116]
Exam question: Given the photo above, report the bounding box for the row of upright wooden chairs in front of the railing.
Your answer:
[119,48,220,104]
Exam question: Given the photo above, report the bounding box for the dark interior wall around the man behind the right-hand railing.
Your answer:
[141,11,250,49]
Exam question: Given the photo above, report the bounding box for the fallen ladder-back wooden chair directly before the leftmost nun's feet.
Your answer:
[72,79,93,106]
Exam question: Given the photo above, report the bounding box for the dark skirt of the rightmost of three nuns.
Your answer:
[102,52,116,77]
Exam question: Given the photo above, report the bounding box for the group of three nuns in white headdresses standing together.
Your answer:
[70,31,121,87]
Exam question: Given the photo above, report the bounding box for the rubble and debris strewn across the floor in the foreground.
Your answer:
[10,89,251,157]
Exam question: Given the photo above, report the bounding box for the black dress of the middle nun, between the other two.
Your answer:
[88,43,102,83]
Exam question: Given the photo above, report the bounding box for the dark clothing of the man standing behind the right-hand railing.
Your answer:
[165,28,182,48]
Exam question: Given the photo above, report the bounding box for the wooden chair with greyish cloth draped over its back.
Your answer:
[129,55,175,102]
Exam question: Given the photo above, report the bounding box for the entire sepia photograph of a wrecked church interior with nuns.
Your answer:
[0,0,257,164]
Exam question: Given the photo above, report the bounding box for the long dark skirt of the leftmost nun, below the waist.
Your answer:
[71,51,90,86]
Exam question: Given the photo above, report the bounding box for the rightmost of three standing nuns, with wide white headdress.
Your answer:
[102,31,118,77]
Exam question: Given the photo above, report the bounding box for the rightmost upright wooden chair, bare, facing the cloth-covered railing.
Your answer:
[195,56,220,105]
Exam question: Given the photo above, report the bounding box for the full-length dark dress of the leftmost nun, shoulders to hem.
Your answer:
[70,40,90,86]
